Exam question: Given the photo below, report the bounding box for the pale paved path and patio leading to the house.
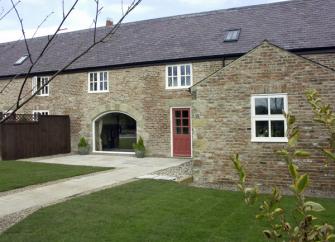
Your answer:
[0,155,188,219]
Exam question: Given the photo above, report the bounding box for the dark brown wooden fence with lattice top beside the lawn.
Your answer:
[0,114,71,160]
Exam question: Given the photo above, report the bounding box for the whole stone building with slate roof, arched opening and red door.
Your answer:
[0,0,335,193]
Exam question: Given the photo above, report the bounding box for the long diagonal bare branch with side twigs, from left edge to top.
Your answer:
[0,0,142,124]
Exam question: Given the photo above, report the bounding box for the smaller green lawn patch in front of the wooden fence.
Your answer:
[0,161,110,192]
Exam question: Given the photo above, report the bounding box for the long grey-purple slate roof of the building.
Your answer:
[0,0,335,77]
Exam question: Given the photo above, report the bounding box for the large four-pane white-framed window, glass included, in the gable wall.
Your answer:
[251,94,288,142]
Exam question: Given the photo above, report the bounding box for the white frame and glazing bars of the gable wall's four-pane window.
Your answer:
[251,93,288,143]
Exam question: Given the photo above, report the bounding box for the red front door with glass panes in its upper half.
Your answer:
[172,108,192,157]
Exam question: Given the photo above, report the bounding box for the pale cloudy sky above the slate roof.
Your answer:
[0,0,283,43]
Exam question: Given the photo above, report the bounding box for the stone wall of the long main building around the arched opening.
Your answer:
[0,60,223,157]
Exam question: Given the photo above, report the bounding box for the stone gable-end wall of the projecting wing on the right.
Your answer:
[192,42,335,195]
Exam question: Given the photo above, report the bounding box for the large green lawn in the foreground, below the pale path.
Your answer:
[0,180,335,242]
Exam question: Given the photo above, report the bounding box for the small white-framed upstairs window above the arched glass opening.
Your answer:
[88,71,109,93]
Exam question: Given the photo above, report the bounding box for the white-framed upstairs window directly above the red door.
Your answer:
[166,64,193,89]
